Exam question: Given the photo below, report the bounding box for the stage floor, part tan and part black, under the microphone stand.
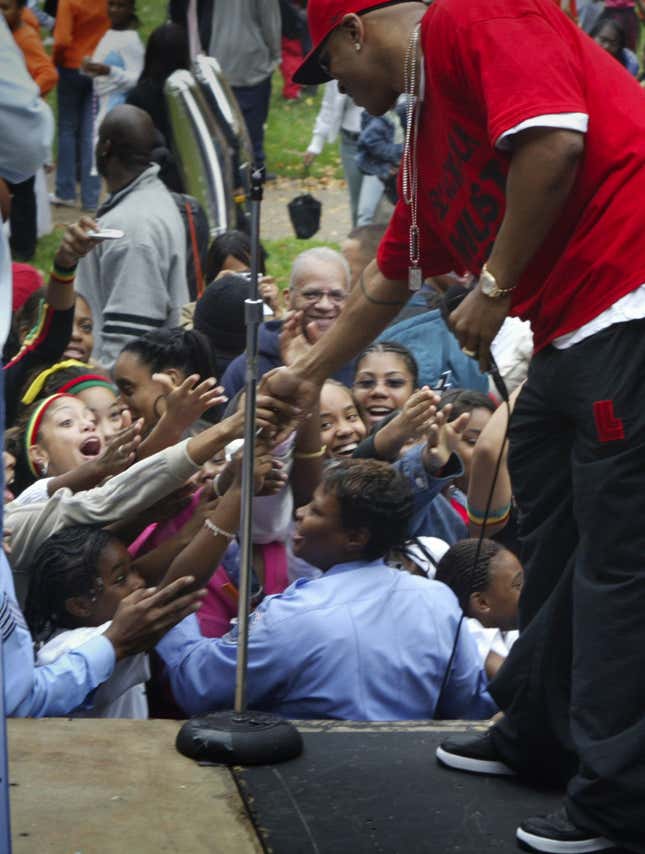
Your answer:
[9,719,620,854]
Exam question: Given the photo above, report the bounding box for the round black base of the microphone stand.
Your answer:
[175,711,302,765]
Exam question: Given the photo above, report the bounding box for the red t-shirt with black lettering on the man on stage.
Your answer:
[378,0,645,350]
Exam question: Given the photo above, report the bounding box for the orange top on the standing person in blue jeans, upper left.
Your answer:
[52,0,110,68]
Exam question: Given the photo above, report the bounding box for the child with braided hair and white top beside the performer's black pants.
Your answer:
[435,538,524,679]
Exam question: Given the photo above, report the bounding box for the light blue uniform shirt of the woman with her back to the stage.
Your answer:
[157,560,497,721]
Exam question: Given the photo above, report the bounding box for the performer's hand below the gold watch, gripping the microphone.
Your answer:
[448,285,511,371]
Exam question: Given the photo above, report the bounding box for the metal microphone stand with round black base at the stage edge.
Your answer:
[177,169,303,765]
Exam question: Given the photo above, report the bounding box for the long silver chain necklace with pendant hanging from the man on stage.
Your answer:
[402,24,423,291]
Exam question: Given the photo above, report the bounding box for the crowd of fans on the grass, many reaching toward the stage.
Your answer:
[0,0,638,720]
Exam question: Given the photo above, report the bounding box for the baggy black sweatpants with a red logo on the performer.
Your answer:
[491,320,645,852]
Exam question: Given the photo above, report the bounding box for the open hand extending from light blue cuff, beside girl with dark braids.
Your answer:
[105,575,205,661]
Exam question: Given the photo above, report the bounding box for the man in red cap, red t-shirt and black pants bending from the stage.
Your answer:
[265,0,645,852]
